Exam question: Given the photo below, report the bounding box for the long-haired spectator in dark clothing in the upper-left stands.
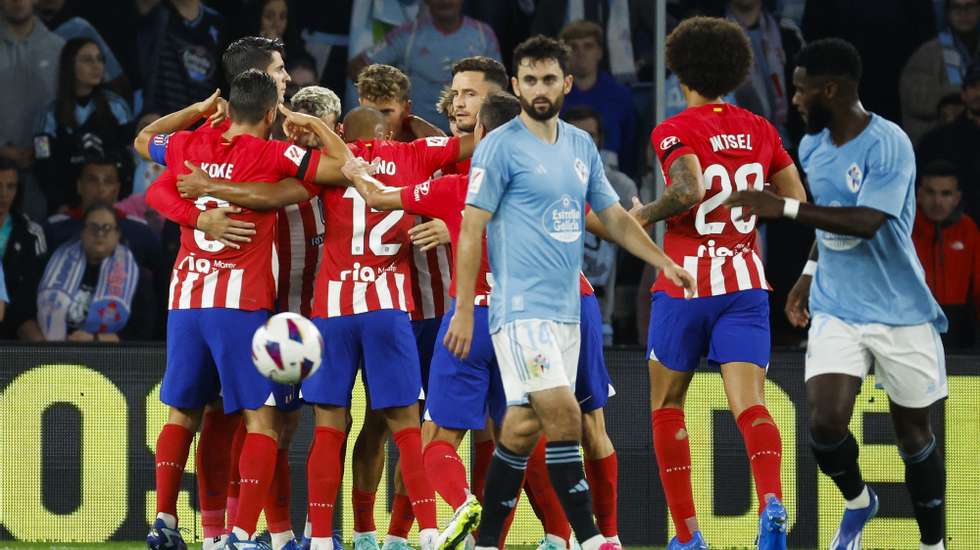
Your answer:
[34,38,133,212]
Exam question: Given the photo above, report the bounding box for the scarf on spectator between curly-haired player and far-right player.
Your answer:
[727,10,789,125]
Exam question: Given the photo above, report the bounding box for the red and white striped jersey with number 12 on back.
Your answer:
[313,137,459,319]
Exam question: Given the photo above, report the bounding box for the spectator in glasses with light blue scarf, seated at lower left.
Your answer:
[37,203,153,342]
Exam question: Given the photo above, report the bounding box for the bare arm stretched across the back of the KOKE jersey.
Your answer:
[177,161,313,210]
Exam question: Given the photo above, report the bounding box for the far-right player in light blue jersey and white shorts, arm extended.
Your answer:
[728,39,948,550]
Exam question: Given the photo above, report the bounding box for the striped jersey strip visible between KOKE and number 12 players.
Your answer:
[276,196,324,317]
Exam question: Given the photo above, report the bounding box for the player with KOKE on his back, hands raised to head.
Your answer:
[134,69,350,548]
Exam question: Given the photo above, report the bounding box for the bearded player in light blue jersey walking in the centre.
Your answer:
[444,36,694,550]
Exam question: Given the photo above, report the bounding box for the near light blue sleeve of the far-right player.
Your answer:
[857,137,915,218]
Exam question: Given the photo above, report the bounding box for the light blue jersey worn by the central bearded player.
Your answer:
[466,118,619,333]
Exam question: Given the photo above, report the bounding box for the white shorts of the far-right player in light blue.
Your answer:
[804,313,949,409]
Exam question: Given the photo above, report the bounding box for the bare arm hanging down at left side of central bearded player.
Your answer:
[442,205,493,359]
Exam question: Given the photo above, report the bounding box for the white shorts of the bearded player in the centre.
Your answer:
[490,319,581,406]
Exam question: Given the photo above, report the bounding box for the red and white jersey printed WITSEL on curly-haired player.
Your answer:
[650,103,793,297]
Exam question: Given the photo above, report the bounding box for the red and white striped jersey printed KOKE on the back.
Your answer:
[164,132,320,310]
